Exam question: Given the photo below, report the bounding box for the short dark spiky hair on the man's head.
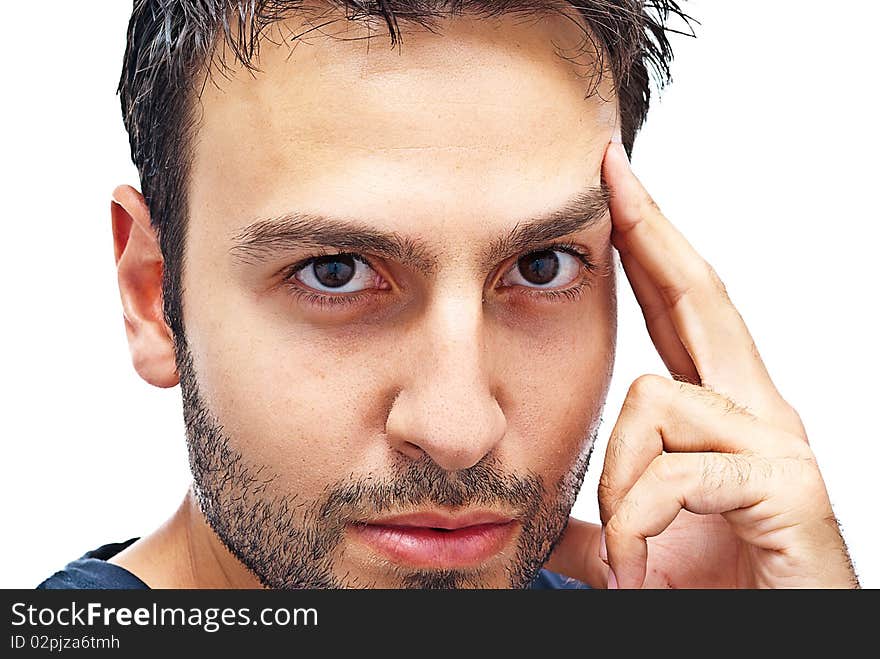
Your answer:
[118,0,692,347]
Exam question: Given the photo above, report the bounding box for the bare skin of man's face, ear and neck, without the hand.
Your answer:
[113,9,617,587]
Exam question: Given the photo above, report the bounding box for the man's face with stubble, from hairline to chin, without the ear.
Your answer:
[181,9,617,587]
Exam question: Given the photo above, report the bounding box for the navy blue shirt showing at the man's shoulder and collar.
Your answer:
[37,538,589,590]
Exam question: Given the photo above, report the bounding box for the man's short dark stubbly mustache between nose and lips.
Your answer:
[316,454,545,522]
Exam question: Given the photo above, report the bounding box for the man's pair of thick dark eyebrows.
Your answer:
[229,182,611,276]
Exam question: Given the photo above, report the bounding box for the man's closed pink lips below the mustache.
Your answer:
[351,511,517,568]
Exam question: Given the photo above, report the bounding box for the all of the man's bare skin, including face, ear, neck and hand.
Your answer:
[105,9,855,588]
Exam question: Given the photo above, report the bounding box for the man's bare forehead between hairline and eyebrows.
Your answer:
[190,8,617,240]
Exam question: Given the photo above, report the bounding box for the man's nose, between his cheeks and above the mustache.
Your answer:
[386,294,507,471]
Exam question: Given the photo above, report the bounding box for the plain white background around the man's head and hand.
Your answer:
[0,0,880,588]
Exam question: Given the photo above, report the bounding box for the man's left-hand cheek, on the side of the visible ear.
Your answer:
[187,284,396,493]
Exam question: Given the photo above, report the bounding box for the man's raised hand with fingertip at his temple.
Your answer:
[547,143,858,588]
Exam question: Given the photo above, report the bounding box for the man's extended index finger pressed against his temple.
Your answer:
[603,143,778,407]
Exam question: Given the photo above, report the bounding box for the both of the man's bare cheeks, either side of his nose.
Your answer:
[185,254,616,495]
